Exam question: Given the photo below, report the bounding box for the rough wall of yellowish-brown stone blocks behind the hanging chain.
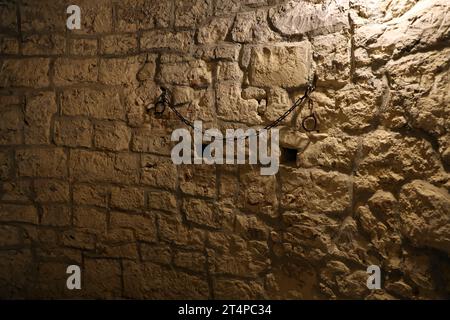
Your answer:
[0,0,450,299]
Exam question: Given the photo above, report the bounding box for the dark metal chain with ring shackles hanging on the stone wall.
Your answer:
[155,76,317,141]
